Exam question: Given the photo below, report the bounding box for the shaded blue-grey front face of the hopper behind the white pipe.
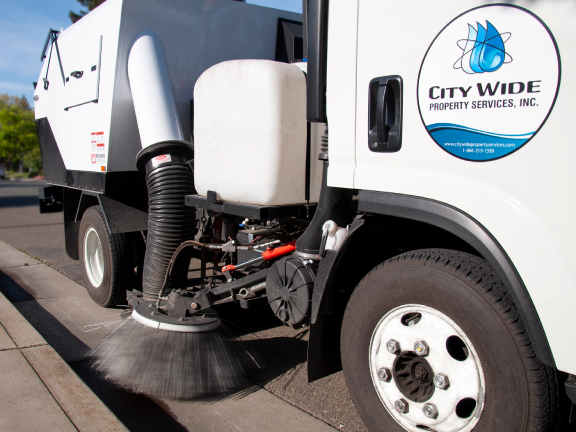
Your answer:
[110,0,302,171]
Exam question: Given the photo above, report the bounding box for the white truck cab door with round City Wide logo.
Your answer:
[354,0,576,378]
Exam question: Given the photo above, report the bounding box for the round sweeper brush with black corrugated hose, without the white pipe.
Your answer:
[90,138,253,399]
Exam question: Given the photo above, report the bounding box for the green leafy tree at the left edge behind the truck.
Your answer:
[0,94,42,172]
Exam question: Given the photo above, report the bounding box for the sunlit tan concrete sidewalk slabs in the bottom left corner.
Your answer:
[0,242,127,432]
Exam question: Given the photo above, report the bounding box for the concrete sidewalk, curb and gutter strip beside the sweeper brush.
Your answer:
[0,241,336,432]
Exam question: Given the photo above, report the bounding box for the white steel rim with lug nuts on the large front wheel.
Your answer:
[369,304,486,432]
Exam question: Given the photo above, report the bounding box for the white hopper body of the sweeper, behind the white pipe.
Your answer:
[34,0,301,176]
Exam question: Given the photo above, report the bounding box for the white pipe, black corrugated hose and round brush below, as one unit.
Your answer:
[90,31,256,399]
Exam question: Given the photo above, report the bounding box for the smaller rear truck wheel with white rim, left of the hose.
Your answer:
[78,206,134,307]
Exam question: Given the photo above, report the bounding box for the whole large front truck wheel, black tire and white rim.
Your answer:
[341,249,558,432]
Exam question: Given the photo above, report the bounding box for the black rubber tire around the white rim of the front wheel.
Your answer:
[341,249,559,432]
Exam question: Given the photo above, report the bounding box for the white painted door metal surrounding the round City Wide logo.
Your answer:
[354,0,576,373]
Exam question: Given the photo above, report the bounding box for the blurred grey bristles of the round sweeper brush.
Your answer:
[88,317,248,399]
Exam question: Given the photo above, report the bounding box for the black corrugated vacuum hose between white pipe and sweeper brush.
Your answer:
[137,141,196,301]
